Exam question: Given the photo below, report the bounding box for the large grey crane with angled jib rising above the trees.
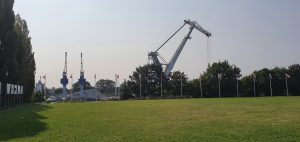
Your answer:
[148,20,211,76]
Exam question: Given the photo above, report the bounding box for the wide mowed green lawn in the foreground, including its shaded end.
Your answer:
[0,97,300,142]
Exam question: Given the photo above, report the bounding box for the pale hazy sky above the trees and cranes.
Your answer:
[14,0,300,87]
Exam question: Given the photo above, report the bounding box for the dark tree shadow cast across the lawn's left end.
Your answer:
[0,104,51,141]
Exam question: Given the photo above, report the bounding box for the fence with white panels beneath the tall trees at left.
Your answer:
[0,82,23,109]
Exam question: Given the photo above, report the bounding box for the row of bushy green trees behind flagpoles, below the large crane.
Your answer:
[120,61,300,99]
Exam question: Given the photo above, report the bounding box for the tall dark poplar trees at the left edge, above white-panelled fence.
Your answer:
[0,0,36,102]
